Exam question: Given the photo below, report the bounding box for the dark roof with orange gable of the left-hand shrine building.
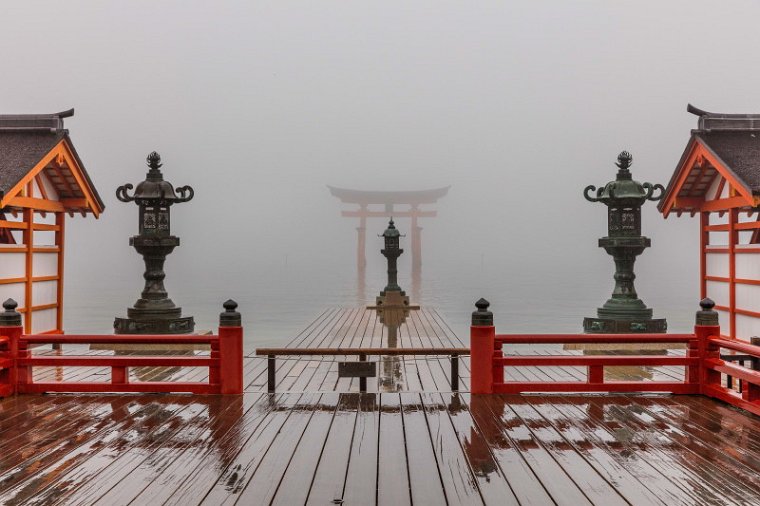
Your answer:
[0,109,105,217]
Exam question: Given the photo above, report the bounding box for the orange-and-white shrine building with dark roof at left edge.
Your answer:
[0,109,105,334]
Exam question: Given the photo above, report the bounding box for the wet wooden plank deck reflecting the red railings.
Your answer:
[0,308,760,506]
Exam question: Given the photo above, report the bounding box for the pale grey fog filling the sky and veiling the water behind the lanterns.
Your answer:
[0,0,760,342]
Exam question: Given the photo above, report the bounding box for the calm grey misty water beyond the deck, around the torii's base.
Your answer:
[65,252,698,347]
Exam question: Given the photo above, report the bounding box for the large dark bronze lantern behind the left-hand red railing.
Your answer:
[114,151,195,334]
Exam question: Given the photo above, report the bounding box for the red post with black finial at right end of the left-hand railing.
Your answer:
[219,299,243,394]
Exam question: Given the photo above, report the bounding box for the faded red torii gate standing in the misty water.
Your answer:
[327,185,450,271]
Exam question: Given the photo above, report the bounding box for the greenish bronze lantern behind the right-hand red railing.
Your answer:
[583,151,667,334]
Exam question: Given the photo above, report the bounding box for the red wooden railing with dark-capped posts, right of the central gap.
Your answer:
[470,299,760,415]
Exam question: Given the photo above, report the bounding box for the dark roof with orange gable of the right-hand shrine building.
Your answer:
[658,104,760,216]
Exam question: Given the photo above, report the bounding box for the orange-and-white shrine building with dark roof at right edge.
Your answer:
[658,105,760,340]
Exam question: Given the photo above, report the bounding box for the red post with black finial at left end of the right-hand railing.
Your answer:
[470,299,496,394]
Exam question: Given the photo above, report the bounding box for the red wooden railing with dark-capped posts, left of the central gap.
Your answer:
[0,301,243,397]
